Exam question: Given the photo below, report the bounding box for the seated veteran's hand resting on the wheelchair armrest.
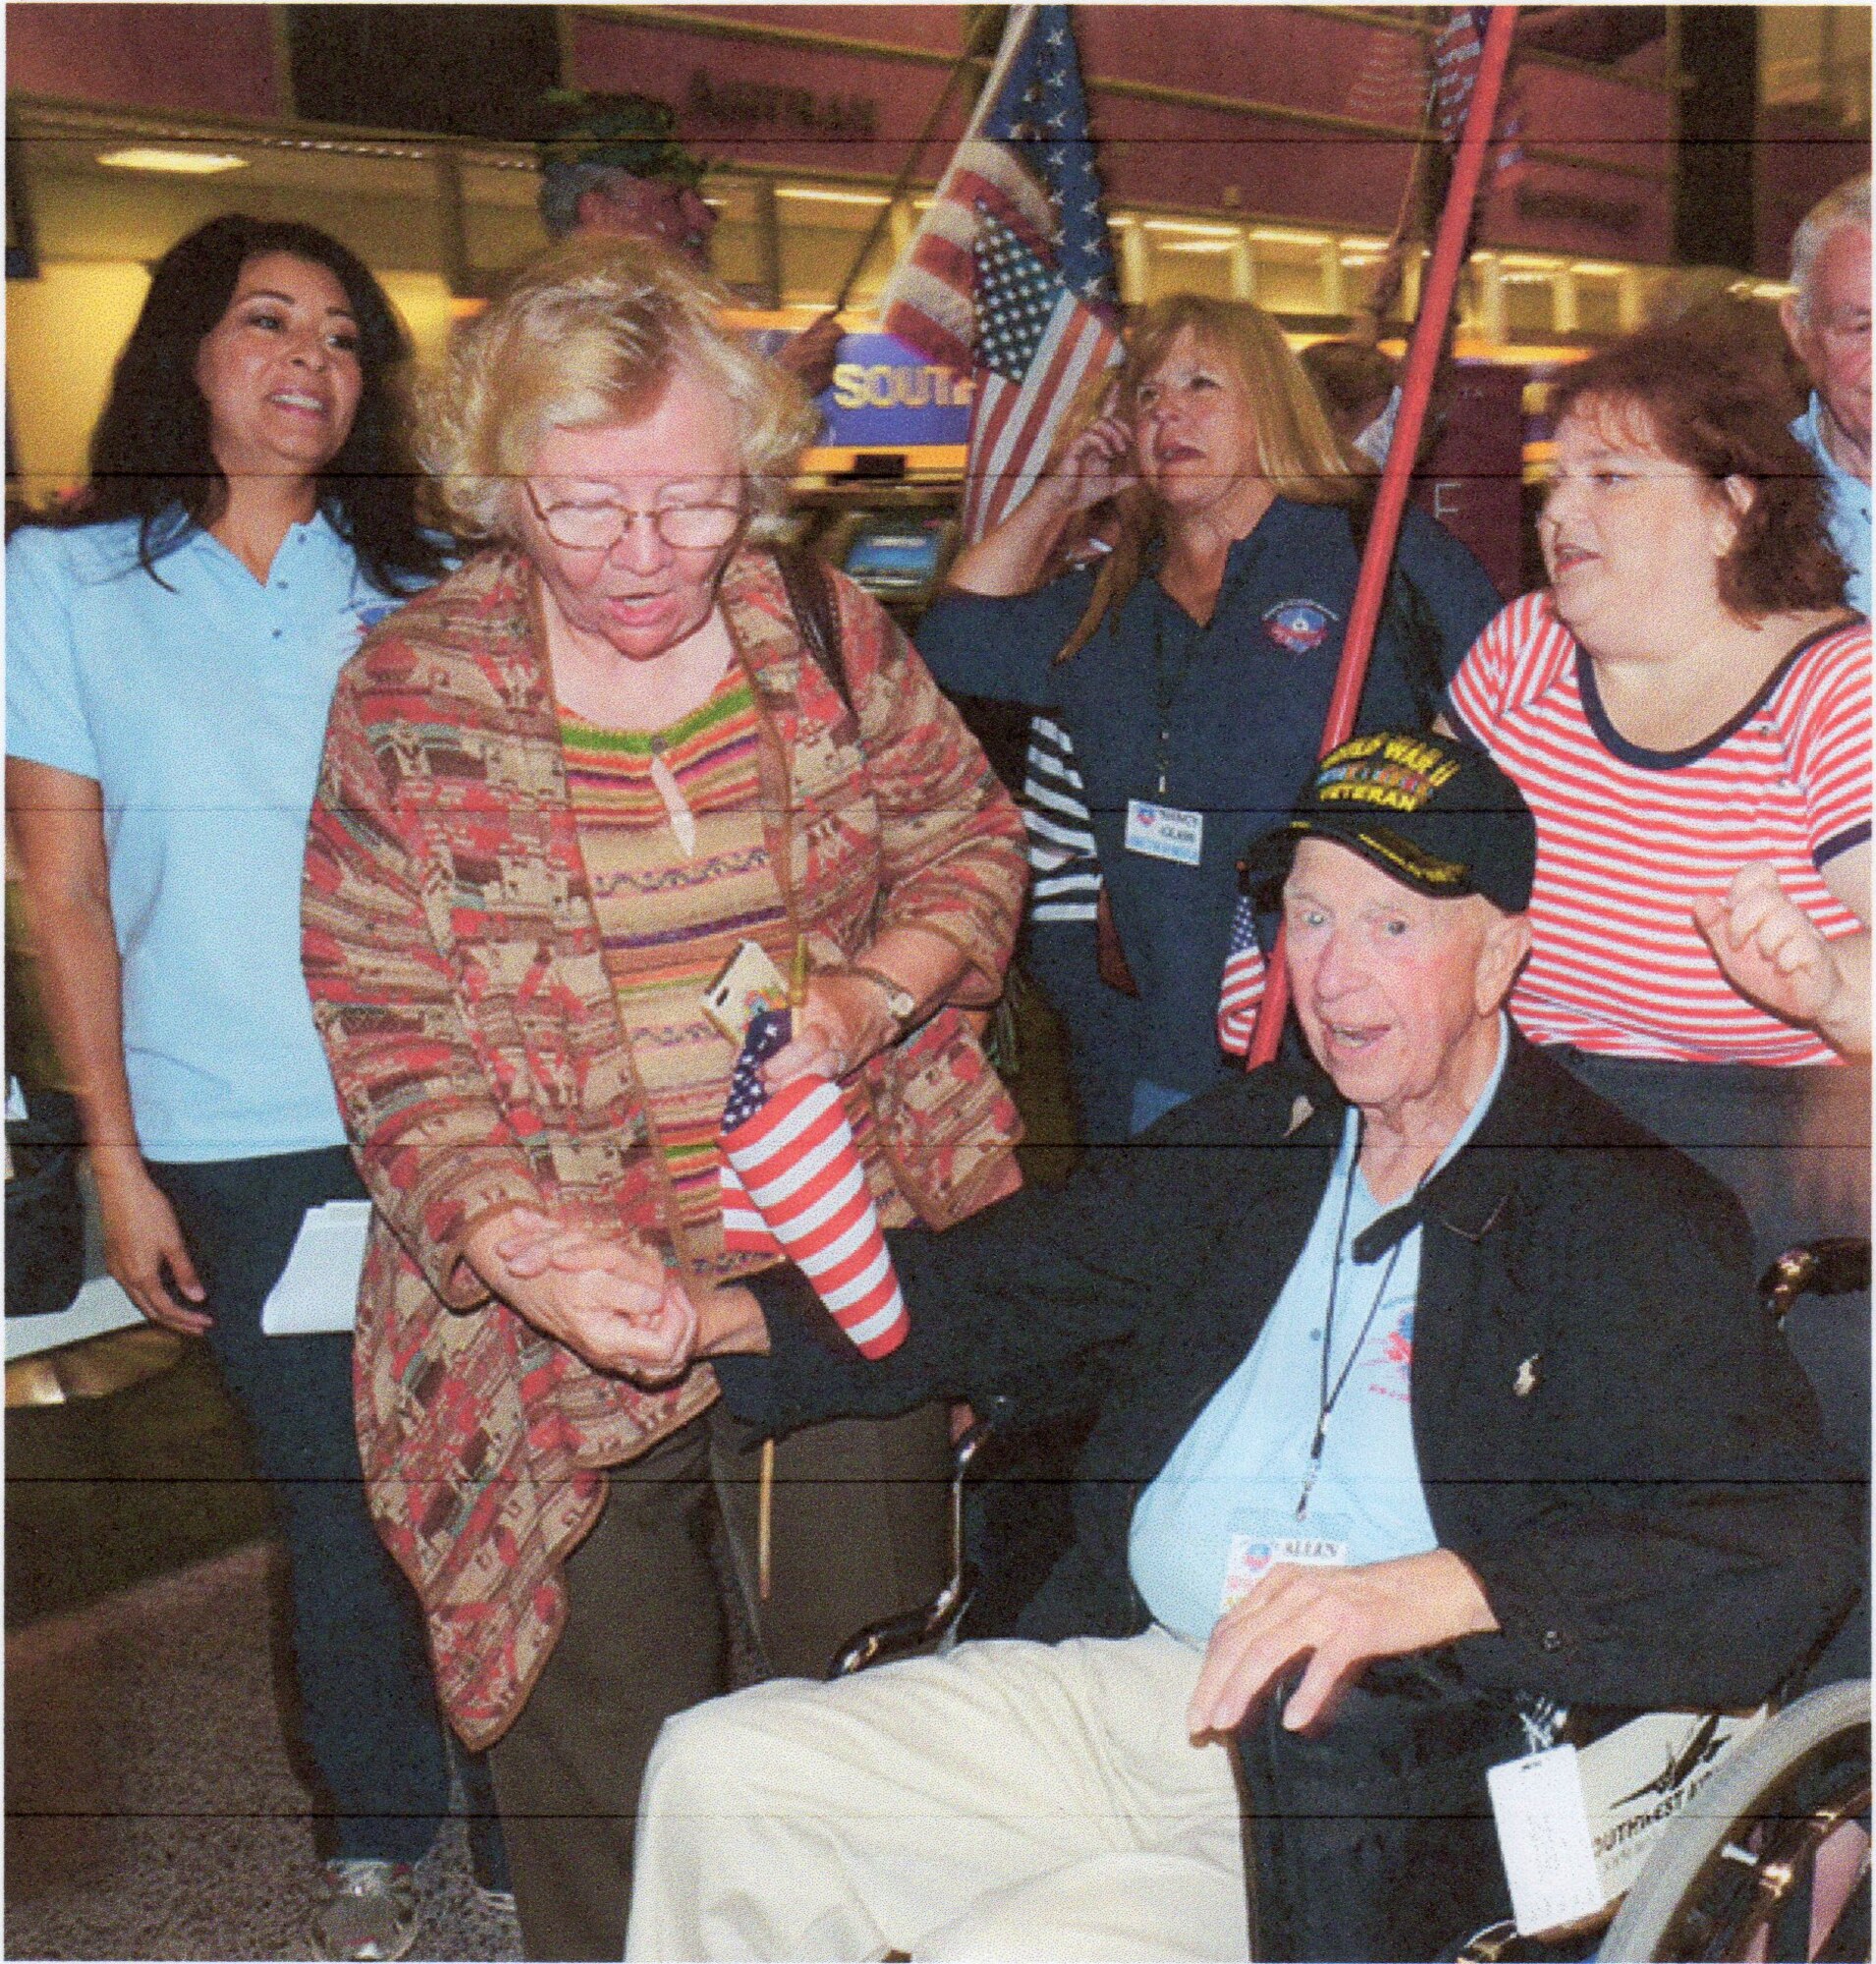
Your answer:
[1186,1548,1499,1738]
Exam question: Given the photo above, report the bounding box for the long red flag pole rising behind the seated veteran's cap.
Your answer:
[1243,6,1518,1070]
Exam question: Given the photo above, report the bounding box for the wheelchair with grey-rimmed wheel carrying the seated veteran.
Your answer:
[827,1237,1870,1964]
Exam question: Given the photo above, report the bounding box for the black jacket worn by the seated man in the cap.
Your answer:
[719,1035,1862,1709]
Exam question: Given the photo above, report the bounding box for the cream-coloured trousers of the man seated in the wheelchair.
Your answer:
[627,1630,1249,1964]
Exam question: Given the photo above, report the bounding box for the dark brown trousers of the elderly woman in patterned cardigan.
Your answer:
[489,1406,951,1958]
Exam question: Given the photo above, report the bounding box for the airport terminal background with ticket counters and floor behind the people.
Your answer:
[6,0,1872,1958]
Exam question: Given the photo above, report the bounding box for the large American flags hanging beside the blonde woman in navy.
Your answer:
[880,6,1120,542]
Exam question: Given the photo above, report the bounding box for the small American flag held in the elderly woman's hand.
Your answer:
[717,1009,911,1357]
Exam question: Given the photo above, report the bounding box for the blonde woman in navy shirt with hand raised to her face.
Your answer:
[917,295,1499,1131]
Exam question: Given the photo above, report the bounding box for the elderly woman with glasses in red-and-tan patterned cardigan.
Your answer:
[304,242,1023,1958]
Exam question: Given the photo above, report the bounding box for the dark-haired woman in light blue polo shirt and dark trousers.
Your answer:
[6,216,505,1958]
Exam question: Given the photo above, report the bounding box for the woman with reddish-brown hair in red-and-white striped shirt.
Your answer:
[1450,320,1870,1461]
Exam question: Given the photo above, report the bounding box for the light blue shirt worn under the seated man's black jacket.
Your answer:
[1128,1017,1507,1644]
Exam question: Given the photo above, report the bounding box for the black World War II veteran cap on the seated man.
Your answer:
[1241,731,1538,913]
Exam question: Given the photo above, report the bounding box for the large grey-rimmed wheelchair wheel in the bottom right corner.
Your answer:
[1597,1681,1870,1964]
